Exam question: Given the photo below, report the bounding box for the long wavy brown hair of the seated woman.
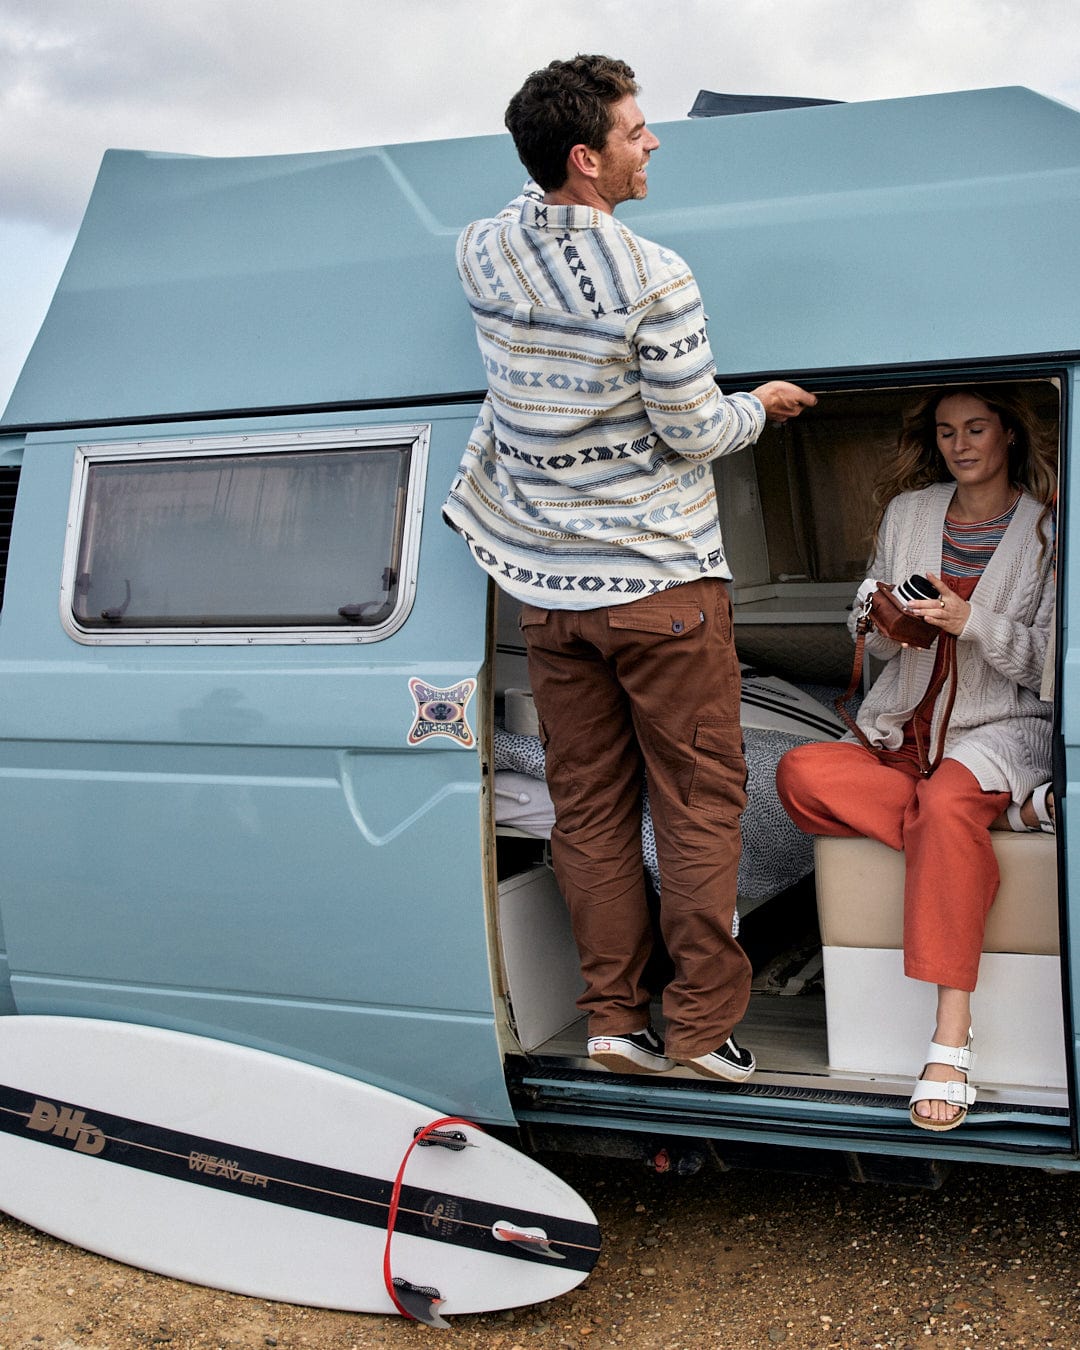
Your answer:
[872,385,1057,551]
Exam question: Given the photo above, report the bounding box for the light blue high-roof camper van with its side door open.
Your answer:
[0,88,1080,1204]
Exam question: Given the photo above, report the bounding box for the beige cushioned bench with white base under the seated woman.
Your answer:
[814,830,1065,1088]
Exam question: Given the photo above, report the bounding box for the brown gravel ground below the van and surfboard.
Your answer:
[0,1156,1080,1350]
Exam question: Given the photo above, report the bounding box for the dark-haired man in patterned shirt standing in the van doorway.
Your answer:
[444,55,817,1081]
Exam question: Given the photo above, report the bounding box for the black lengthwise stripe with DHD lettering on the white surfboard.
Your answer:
[0,1084,599,1272]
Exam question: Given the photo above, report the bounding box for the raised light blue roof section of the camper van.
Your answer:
[3,89,1080,428]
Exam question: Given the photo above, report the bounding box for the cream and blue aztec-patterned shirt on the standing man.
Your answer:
[444,184,765,609]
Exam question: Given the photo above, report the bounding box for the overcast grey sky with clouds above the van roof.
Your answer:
[0,0,1080,408]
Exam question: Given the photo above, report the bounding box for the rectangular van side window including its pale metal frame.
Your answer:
[65,427,427,643]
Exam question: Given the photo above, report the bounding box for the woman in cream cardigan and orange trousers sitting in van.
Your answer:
[776,386,1056,1130]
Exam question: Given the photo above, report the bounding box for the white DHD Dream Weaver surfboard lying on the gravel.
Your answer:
[0,1015,599,1324]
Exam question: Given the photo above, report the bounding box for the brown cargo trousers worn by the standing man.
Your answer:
[521,579,751,1058]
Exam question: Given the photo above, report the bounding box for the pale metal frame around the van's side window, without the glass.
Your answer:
[59,423,431,647]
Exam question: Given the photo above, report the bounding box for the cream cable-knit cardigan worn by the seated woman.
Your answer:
[848,482,1054,802]
